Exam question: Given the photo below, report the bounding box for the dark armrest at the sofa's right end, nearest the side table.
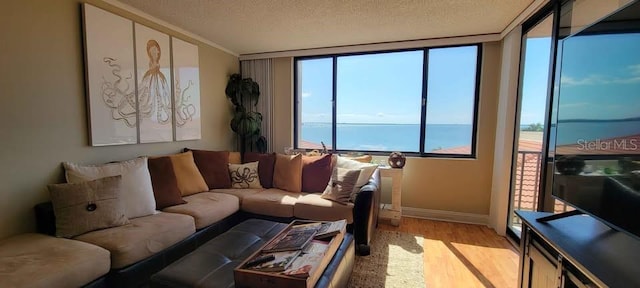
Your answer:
[353,169,380,255]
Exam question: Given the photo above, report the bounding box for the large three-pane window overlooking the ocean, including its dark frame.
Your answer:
[294,45,480,157]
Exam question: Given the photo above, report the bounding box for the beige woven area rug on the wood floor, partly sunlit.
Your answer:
[348,230,425,288]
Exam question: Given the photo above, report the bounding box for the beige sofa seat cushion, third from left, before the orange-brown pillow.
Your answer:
[162,192,240,229]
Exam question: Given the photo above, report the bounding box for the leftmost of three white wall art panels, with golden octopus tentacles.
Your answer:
[83,3,137,146]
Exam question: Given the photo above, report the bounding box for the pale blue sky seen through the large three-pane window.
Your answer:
[298,46,477,124]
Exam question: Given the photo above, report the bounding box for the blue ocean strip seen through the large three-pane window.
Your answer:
[300,123,473,152]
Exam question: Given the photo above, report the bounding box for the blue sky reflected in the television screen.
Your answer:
[558,33,640,121]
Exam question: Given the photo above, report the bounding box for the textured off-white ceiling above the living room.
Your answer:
[117,0,533,55]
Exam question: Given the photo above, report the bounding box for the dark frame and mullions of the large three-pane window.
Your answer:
[293,43,483,159]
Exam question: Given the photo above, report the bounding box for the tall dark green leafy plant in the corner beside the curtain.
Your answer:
[225,73,267,155]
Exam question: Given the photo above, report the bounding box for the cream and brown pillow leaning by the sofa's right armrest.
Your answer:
[320,168,361,204]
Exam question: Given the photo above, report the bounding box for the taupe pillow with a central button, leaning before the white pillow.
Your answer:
[47,175,129,238]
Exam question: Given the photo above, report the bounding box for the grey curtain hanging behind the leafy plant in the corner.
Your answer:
[240,59,273,152]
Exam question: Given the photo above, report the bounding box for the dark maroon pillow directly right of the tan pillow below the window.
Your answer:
[302,154,332,193]
